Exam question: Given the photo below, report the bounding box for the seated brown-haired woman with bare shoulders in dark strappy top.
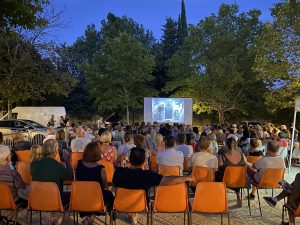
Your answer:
[216,136,247,207]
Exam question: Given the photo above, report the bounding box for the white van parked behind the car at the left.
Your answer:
[12,106,66,127]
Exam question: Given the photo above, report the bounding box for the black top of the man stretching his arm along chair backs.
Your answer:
[113,167,163,191]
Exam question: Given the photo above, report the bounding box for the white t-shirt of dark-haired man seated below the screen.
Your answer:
[157,148,184,171]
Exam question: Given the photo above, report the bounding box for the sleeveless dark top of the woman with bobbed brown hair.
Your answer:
[76,160,104,187]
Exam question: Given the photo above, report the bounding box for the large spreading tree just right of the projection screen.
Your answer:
[166,4,263,124]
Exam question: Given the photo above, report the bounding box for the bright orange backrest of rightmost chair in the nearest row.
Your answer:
[192,182,228,213]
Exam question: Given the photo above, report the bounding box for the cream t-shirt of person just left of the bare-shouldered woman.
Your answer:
[189,152,218,170]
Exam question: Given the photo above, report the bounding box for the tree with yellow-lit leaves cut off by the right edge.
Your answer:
[253,3,300,112]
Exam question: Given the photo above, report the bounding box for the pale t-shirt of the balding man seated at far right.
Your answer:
[254,156,285,182]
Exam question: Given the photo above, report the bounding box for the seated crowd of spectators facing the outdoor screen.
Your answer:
[0,123,300,224]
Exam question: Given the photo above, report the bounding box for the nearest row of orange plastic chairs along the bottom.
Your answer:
[0,181,230,224]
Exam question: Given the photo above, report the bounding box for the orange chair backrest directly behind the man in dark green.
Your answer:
[28,181,64,212]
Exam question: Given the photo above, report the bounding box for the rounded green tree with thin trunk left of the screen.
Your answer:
[84,32,155,124]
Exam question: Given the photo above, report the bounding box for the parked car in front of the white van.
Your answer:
[0,119,47,146]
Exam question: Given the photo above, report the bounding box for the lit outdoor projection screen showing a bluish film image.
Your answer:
[144,98,193,125]
